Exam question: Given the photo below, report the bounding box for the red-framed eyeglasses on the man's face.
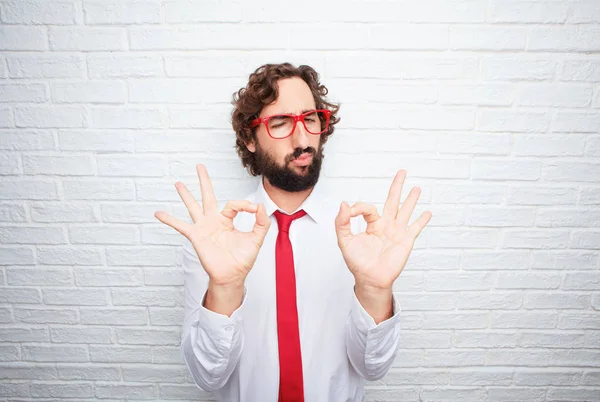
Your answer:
[250,109,331,140]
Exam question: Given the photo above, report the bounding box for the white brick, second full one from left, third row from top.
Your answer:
[87,52,164,78]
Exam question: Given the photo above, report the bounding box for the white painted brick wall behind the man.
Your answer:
[0,0,600,401]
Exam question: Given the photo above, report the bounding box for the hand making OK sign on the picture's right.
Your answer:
[335,170,432,289]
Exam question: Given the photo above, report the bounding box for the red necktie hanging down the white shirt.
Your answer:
[275,210,306,402]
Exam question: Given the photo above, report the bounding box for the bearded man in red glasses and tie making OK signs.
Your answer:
[155,63,431,402]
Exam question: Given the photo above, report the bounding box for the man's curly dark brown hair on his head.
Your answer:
[231,63,340,176]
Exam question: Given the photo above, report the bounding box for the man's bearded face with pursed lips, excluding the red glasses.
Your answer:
[247,77,324,192]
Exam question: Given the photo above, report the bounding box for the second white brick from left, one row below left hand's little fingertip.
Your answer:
[69,224,140,244]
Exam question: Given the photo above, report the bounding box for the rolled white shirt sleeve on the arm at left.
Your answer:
[181,241,246,391]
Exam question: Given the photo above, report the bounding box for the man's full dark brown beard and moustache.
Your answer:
[255,142,324,193]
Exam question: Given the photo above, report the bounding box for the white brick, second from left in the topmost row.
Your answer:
[83,0,161,25]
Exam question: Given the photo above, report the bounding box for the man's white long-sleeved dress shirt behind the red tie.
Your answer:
[181,180,400,402]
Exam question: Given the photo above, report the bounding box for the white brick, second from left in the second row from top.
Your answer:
[48,27,127,51]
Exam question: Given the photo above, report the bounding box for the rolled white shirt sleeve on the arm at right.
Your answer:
[346,291,401,381]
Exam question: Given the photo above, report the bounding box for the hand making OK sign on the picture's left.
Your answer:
[154,164,271,296]
